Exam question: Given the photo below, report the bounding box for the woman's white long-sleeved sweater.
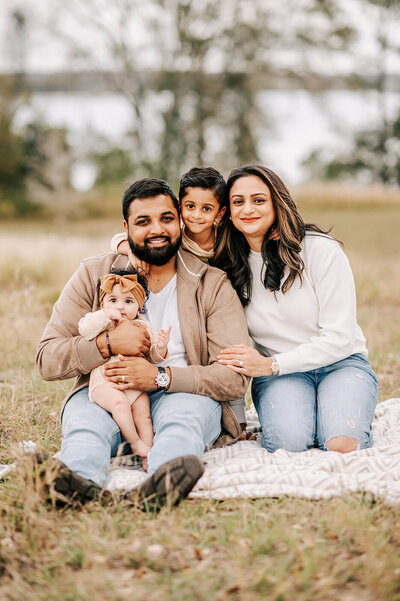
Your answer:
[246,233,368,374]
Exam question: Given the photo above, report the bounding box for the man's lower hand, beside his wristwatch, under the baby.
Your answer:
[103,355,158,390]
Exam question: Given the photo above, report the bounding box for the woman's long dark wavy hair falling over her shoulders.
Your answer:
[213,165,330,307]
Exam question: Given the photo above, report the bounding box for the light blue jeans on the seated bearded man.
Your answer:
[61,388,221,487]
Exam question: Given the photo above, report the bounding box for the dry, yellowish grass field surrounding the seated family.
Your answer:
[0,198,400,601]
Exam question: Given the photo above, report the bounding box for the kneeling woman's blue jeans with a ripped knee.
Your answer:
[252,354,378,453]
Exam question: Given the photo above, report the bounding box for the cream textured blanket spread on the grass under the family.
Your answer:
[109,399,400,504]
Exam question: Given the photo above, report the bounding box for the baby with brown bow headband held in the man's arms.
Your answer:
[79,268,171,468]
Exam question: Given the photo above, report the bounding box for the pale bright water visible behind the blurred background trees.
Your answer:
[14,90,400,189]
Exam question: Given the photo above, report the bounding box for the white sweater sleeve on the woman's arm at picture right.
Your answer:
[275,239,357,374]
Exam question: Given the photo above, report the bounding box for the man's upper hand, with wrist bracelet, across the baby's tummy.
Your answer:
[96,320,150,358]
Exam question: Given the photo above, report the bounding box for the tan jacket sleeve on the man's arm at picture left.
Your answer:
[36,261,106,380]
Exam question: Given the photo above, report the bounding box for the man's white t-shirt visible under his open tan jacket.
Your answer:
[140,274,188,367]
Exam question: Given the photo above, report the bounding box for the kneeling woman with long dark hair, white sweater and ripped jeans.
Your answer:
[215,165,378,453]
